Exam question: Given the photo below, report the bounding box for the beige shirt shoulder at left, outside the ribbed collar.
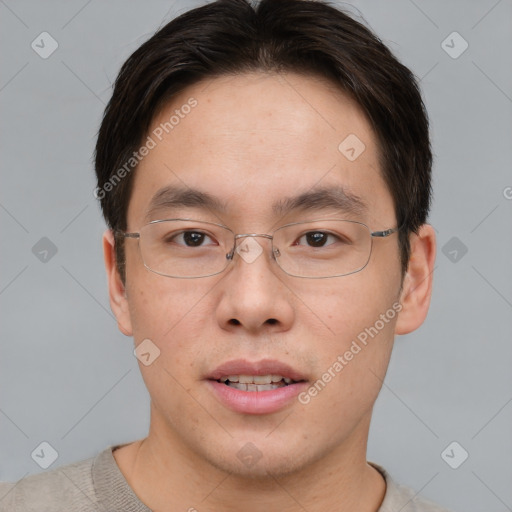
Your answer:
[0,450,97,512]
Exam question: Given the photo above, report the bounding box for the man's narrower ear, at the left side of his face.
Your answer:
[103,229,133,336]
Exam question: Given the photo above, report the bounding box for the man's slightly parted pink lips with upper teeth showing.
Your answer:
[207,359,308,414]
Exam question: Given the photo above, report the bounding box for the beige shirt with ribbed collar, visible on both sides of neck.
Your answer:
[0,446,449,512]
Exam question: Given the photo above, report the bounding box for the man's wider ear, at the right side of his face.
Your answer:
[395,224,436,334]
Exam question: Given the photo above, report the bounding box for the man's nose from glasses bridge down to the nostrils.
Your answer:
[216,234,295,334]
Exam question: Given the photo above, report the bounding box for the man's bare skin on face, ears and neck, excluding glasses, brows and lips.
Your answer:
[103,73,435,512]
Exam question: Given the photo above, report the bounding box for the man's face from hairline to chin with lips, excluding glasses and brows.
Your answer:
[105,73,428,476]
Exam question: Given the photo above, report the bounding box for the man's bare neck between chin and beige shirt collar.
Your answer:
[114,417,386,512]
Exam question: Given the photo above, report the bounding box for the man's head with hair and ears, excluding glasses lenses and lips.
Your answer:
[96,0,435,476]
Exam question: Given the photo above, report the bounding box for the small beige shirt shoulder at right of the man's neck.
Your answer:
[370,462,451,512]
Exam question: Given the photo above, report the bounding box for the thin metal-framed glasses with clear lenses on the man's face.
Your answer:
[115,219,398,279]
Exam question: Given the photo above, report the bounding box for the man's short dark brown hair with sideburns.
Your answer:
[95,0,432,281]
